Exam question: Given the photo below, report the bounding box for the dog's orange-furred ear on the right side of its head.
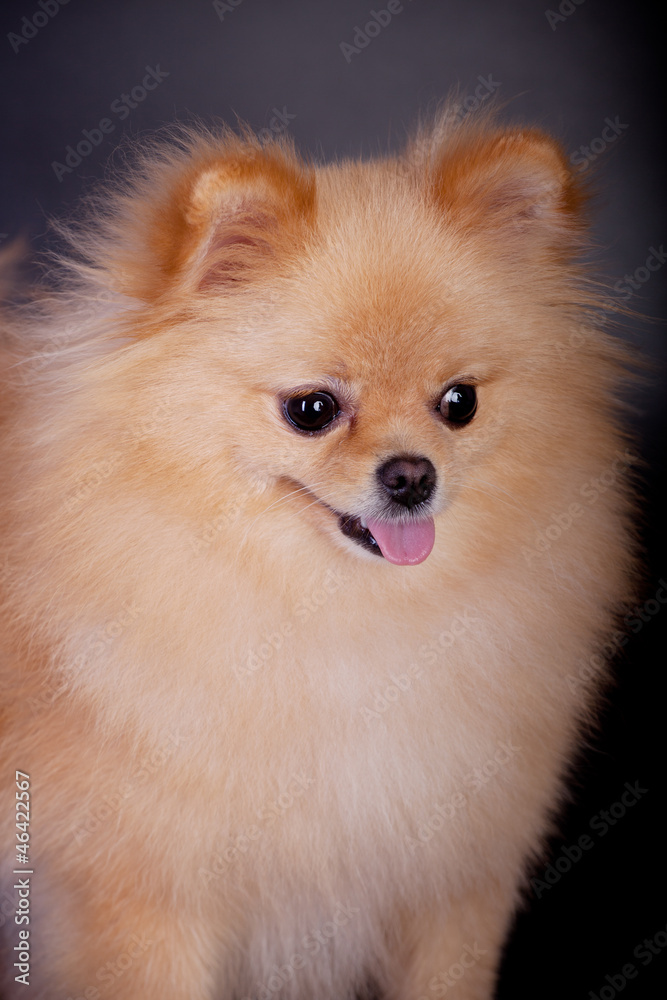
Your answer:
[428,126,586,253]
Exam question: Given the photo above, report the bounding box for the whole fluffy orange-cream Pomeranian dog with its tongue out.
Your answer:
[0,108,636,1000]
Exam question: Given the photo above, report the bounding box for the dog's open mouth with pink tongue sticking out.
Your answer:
[334,511,435,566]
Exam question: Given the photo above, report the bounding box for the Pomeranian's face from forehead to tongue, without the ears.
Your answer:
[222,202,507,564]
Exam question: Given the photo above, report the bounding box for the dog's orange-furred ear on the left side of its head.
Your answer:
[108,136,315,301]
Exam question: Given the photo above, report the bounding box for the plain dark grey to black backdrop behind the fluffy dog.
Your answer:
[0,0,667,1000]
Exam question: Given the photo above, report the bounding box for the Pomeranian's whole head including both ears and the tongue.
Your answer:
[108,121,588,564]
